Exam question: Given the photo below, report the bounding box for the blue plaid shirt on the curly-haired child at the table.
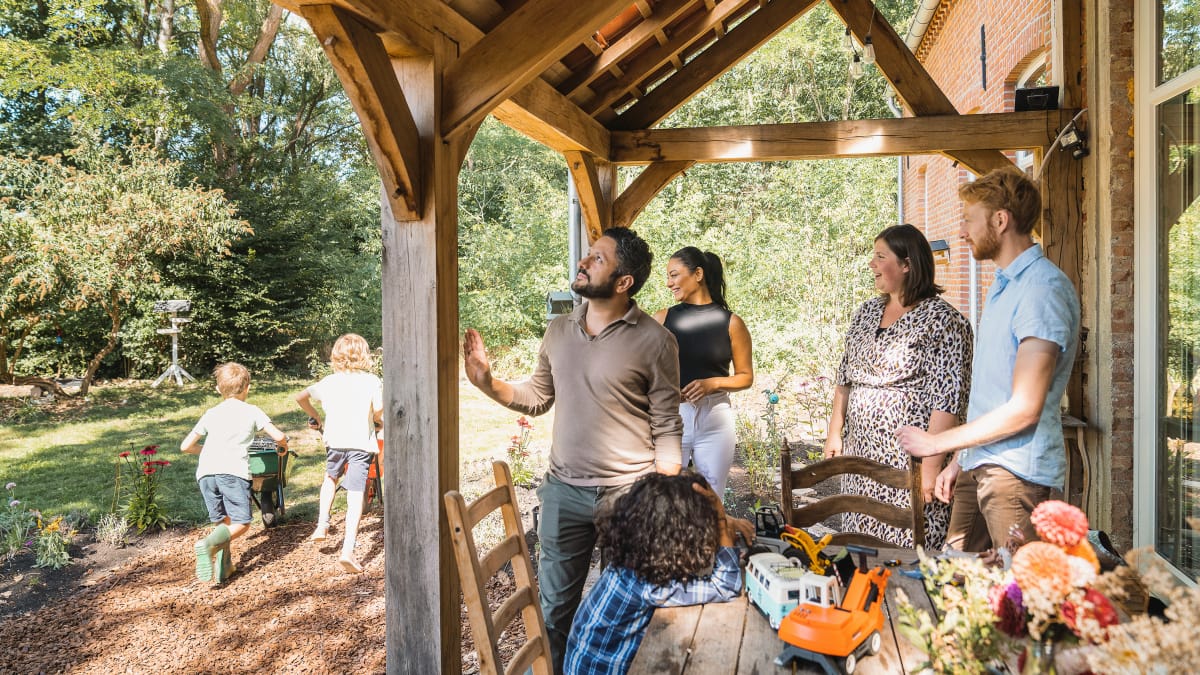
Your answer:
[564,546,742,675]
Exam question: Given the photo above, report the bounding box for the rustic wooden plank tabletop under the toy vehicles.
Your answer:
[630,549,932,675]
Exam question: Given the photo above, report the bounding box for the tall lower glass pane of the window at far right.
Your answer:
[1154,86,1200,578]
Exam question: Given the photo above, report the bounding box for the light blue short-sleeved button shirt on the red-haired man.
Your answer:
[959,245,1079,490]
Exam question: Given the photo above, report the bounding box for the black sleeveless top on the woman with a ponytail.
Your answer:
[662,303,733,387]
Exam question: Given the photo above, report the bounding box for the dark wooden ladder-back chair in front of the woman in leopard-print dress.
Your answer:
[779,438,925,548]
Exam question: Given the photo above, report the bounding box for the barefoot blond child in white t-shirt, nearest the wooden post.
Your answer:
[296,333,383,573]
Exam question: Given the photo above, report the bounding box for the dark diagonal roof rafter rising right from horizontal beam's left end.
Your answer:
[608,0,818,130]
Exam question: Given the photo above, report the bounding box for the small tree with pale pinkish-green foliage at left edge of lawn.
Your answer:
[0,145,251,395]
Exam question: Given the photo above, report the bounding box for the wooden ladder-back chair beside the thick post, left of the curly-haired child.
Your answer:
[444,461,552,675]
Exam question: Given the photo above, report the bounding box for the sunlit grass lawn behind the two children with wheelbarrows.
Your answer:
[0,378,552,524]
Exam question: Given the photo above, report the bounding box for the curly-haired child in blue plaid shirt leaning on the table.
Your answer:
[564,473,742,675]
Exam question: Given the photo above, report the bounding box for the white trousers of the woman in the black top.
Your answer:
[679,392,737,500]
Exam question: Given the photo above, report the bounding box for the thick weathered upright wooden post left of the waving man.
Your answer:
[382,28,478,674]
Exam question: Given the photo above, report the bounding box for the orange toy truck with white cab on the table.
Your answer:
[775,546,892,675]
